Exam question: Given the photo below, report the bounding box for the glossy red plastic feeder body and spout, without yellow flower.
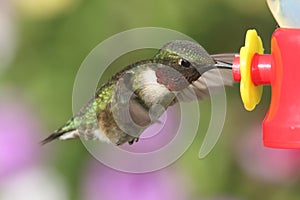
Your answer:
[232,28,300,149]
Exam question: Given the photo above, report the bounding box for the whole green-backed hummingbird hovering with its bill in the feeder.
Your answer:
[41,40,234,145]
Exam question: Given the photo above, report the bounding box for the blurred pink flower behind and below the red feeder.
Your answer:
[237,126,300,183]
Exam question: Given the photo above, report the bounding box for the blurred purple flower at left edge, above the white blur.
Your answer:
[0,91,40,180]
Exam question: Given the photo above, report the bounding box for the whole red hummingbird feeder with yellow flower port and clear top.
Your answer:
[232,0,300,149]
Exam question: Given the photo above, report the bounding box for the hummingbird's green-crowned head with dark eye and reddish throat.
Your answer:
[154,40,216,91]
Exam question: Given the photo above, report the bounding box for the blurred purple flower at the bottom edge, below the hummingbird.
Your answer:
[82,161,189,200]
